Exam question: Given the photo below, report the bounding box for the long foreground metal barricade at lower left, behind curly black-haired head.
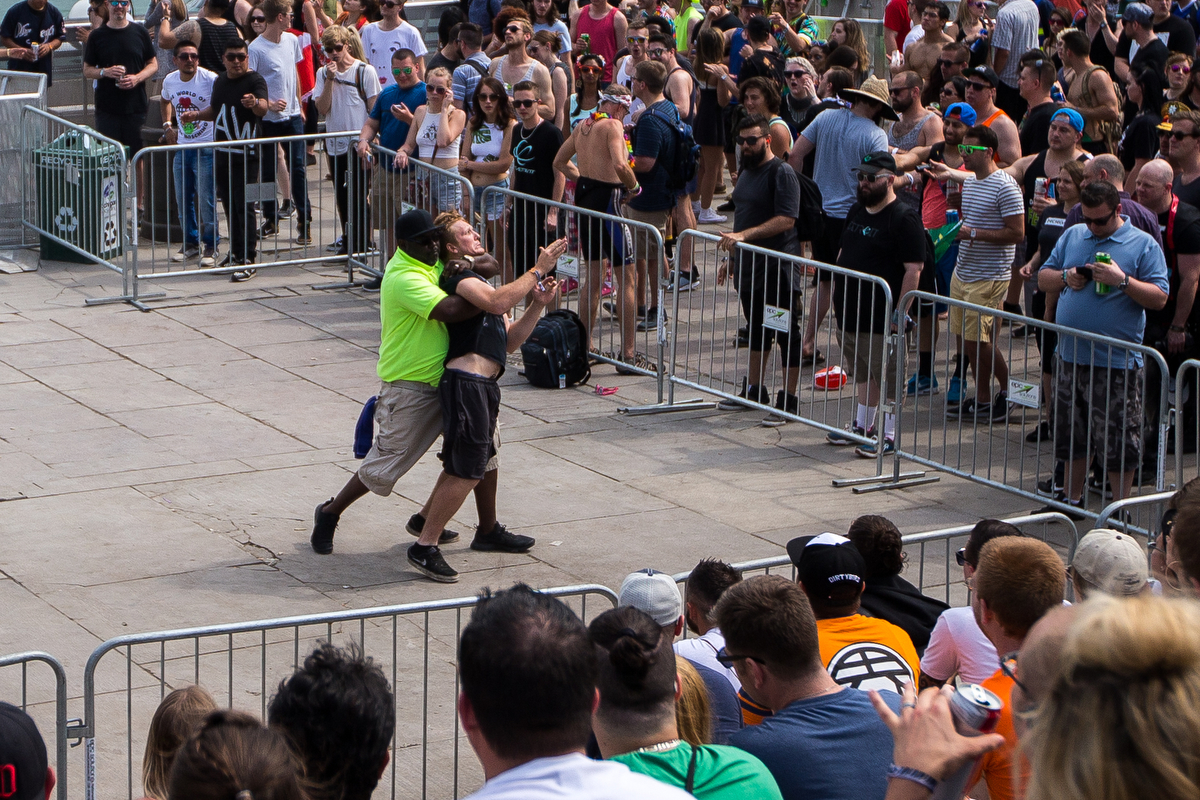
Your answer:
[78,584,617,800]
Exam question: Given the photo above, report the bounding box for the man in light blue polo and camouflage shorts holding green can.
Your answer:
[1038,181,1170,506]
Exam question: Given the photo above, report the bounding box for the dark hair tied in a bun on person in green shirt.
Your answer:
[588,606,676,715]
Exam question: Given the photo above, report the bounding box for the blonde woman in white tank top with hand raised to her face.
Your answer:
[396,67,467,213]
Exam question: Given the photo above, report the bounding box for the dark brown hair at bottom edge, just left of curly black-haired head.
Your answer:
[168,709,306,800]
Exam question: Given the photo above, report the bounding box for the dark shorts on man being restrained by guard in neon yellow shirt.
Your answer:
[438,369,500,481]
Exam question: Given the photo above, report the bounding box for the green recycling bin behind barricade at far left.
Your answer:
[34,131,124,264]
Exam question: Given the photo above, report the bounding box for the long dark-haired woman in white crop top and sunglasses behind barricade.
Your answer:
[458,78,516,255]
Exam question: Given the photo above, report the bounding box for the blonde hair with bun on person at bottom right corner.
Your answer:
[1022,596,1200,800]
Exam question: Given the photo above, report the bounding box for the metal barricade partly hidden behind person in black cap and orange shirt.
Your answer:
[672,511,1079,606]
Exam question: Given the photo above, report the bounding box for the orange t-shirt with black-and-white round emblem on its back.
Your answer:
[817,614,920,694]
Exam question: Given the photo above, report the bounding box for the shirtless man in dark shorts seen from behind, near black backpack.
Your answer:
[554,84,638,369]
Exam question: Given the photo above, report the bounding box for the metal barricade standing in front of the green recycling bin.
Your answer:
[20,106,145,303]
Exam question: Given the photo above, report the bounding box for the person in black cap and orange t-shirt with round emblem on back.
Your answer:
[787,533,920,693]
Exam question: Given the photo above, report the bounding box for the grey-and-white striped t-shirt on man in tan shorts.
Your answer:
[955,169,1025,283]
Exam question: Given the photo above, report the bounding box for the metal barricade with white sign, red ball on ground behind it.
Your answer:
[630,230,928,486]
